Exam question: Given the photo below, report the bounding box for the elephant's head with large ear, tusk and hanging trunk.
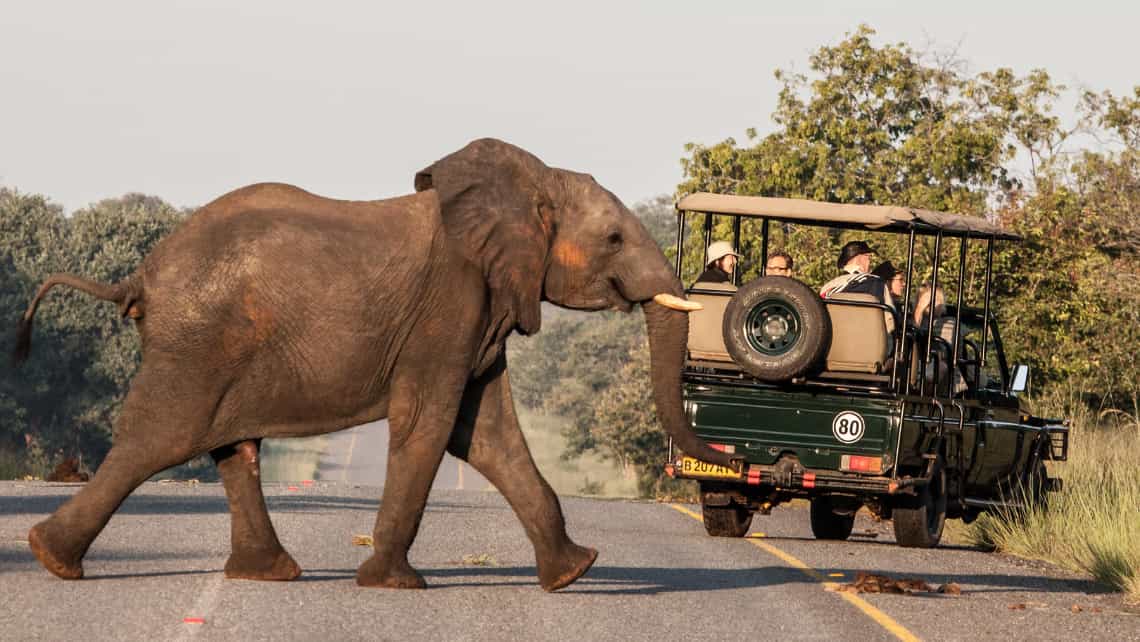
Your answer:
[415,139,739,466]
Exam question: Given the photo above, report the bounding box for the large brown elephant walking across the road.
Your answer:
[14,139,741,591]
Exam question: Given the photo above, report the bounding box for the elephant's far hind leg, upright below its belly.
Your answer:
[210,439,301,580]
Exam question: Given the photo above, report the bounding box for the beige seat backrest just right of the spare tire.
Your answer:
[824,292,890,374]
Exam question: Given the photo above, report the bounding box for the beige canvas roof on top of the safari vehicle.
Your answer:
[677,192,1021,241]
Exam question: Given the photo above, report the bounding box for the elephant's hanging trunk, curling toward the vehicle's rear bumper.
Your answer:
[642,300,738,468]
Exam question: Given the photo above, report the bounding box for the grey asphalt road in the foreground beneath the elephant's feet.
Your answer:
[0,481,1140,640]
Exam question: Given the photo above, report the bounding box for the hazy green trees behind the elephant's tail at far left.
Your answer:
[0,189,181,468]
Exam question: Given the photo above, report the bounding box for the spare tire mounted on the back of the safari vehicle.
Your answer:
[722,276,831,383]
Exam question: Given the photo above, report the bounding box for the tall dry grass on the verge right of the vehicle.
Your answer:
[967,399,1140,603]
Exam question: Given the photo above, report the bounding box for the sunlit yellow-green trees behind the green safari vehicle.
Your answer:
[524,27,1140,497]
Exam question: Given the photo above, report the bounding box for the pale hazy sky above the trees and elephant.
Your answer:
[0,0,1140,210]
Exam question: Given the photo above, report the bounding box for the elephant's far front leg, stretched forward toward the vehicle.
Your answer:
[448,357,597,591]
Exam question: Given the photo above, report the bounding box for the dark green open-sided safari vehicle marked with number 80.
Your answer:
[666,194,1068,547]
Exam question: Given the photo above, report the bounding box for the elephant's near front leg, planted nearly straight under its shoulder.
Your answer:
[357,376,462,588]
